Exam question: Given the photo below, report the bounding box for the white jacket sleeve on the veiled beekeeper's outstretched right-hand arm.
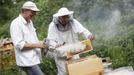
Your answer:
[73,19,92,38]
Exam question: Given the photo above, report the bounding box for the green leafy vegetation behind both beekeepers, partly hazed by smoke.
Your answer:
[0,0,134,75]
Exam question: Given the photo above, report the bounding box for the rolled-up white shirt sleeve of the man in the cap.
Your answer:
[10,22,25,50]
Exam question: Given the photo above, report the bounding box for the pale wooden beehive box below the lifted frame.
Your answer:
[66,57,104,75]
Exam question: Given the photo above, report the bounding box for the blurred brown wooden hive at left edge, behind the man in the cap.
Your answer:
[0,38,14,69]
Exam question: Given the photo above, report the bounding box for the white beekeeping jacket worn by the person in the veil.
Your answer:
[47,17,92,48]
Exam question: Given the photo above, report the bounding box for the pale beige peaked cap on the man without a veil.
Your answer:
[22,1,40,11]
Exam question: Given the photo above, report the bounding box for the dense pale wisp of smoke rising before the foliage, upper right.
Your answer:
[105,10,121,39]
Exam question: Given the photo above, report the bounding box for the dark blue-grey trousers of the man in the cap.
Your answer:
[19,65,44,75]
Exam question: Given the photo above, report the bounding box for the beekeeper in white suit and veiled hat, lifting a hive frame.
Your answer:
[47,7,94,75]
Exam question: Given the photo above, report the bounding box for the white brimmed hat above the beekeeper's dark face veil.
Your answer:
[53,7,74,17]
